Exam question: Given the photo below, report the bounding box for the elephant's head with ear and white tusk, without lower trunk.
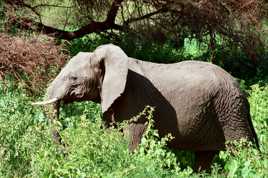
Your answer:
[33,44,128,116]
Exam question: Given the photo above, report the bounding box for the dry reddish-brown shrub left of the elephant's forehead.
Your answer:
[0,33,68,93]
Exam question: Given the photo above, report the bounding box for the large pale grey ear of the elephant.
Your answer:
[95,44,128,113]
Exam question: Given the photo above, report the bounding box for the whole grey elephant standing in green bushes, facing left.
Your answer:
[31,44,259,170]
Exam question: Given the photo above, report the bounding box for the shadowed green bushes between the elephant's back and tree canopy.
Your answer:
[66,34,268,80]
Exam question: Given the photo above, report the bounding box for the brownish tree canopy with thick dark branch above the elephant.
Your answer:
[3,0,268,60]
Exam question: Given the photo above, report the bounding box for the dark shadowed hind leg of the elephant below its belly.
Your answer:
[194,151,218,171]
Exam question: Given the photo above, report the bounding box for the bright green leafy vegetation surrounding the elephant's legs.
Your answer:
[0,62,268,177]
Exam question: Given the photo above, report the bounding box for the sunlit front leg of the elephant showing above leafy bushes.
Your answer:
[123,123,147,152]
